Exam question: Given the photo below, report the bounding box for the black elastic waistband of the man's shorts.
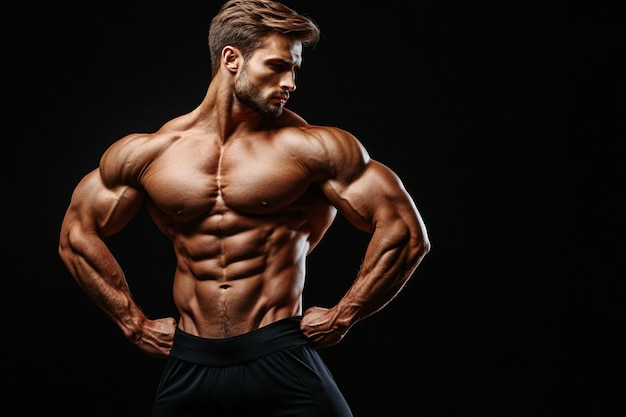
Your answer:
[170,316,308,366]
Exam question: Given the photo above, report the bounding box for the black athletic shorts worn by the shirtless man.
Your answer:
[152,317,352,417]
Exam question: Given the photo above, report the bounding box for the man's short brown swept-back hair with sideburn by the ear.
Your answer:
[209,0,320,75]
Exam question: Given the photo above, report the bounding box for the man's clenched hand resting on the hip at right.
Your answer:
[300,307,349,348]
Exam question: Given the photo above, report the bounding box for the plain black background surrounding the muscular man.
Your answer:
[1,0,626,417]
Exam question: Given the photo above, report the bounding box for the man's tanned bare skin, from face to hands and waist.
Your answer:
[59,34,430,357]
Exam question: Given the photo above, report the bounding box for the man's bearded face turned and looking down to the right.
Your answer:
[235,34,302,118]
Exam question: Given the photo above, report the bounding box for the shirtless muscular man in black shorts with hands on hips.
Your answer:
[59,0,429,417]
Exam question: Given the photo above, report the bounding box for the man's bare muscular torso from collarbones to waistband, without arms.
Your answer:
[130,116,335,338]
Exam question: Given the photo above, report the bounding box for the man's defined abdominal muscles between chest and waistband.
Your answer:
[162,204,309,338]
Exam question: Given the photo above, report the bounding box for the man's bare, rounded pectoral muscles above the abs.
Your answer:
[142,136,311,219]
